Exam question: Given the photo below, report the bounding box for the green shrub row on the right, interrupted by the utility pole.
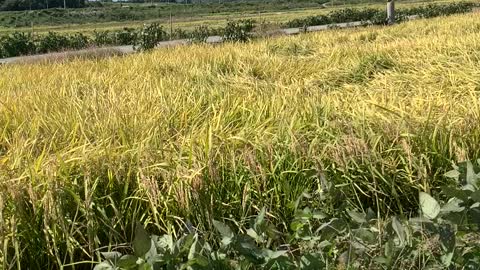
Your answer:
[285,2,476,27]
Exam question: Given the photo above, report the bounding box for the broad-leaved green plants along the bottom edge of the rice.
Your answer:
[95,160,480,269]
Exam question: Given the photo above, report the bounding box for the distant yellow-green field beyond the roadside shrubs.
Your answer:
[0,0,462,34]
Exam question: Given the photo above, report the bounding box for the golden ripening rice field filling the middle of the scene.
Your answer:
[0,14,480,269]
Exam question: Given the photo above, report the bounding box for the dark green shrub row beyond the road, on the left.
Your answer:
[0,20,255,58]
